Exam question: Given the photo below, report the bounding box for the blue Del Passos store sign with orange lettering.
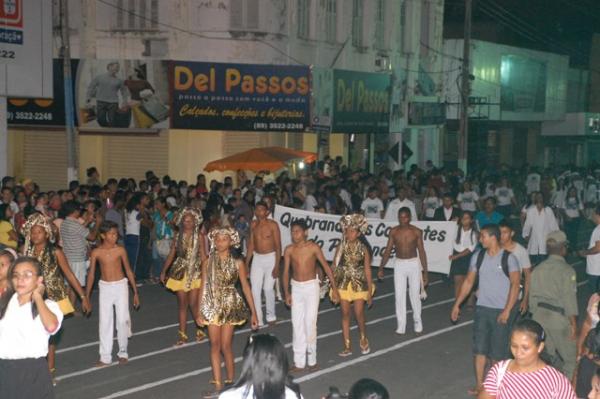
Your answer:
[170,61,310,132]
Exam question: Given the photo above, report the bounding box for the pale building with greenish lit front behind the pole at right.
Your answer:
[444,39,586,168]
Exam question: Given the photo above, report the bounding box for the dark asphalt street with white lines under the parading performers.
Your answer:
[50,255,591,399]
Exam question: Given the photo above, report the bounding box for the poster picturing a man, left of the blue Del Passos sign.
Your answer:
[75,60,169,129]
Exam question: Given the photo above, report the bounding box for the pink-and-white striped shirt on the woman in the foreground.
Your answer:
[483,360,577,399]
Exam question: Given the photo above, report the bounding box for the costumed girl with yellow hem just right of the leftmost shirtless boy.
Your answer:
[160,208,206,346]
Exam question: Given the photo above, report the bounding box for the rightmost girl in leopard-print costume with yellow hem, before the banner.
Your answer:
[333,214,374,357]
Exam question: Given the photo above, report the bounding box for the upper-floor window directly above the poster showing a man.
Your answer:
[116,0,158,31]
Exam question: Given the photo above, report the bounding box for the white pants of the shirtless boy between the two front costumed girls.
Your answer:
[292,279,319,368]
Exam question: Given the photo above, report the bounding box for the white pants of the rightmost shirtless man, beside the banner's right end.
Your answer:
[393,258,423,334]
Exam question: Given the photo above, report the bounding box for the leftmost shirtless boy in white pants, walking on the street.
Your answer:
[86,221,140,367]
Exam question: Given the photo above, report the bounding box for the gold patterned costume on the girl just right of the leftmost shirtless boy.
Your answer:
[169,232,202,291]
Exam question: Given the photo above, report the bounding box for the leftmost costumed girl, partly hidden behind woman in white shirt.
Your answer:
[21,213,92,382]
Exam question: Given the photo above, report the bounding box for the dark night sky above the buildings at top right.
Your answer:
[444,0,600,66]
